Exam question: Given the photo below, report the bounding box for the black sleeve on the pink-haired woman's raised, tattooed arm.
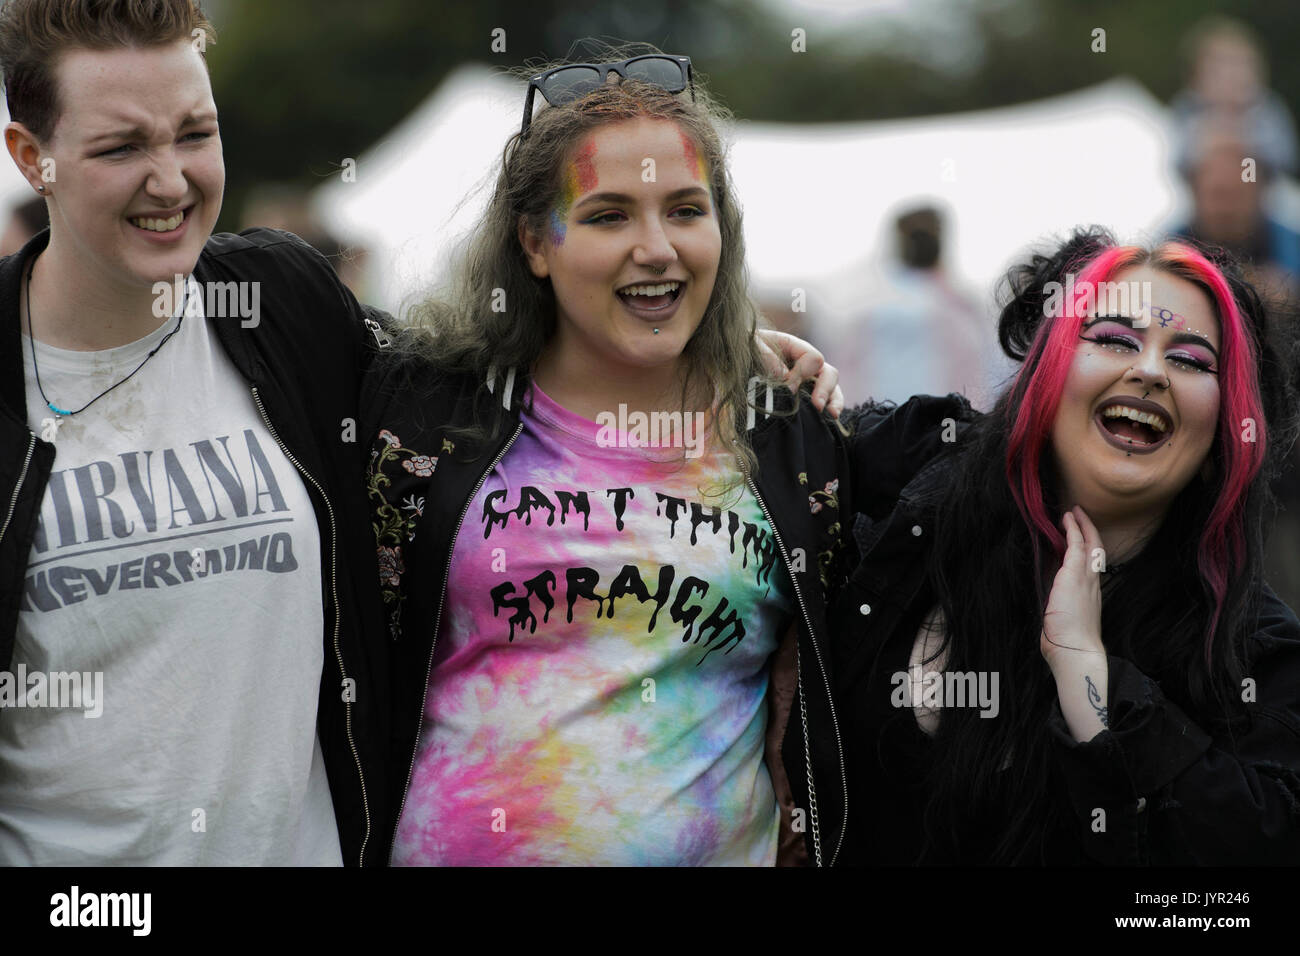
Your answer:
[1049,592,1300,865]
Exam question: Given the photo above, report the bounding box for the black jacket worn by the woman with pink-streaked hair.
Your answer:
[831,395,1300,865]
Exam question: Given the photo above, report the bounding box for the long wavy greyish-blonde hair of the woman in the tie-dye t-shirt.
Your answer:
[398,44,781,471]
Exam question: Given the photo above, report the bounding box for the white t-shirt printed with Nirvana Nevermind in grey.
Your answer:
[0,278,342,866]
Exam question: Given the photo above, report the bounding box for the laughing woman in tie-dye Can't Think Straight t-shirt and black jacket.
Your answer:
[364,51,846,865]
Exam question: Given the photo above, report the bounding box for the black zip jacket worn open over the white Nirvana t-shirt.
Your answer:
[0,229,387,865]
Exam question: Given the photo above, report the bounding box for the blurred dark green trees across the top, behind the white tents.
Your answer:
[209,0,1300,229]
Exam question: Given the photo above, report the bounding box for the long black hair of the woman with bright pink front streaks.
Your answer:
[923,228,1295,864]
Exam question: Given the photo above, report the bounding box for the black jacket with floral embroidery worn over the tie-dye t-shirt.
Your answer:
[363,362,850,865]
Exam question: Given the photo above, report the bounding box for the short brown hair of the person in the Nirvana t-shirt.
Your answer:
[0,0,217,142]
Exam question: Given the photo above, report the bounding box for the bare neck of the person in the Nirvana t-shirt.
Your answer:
[18,237,172,351]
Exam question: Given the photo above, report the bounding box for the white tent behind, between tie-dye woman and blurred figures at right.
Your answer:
[732,79,1178,315]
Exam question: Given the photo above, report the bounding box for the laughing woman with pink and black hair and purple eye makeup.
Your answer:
[832,229,1300,865]
